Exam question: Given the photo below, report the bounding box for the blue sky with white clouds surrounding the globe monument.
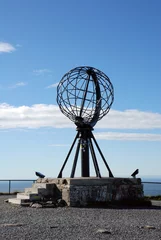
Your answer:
[0,0,161,179]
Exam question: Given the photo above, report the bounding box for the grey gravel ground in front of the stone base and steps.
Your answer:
[0,196,161,240]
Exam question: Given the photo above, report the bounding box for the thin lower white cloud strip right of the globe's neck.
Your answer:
[95,132,161,141]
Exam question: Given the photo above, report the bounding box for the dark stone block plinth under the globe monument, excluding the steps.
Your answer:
[34,177,144,207]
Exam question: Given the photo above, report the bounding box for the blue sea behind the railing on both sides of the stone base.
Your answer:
[0,178,161,196]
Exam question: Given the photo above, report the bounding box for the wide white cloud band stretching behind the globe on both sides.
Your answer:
[0,103,161,134]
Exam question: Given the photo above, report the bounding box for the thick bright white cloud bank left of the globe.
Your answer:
[0,103,73,129]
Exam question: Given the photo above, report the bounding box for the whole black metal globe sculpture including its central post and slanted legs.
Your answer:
[57,66,114,178]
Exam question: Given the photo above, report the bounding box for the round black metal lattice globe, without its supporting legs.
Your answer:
[57,66,114,127]
